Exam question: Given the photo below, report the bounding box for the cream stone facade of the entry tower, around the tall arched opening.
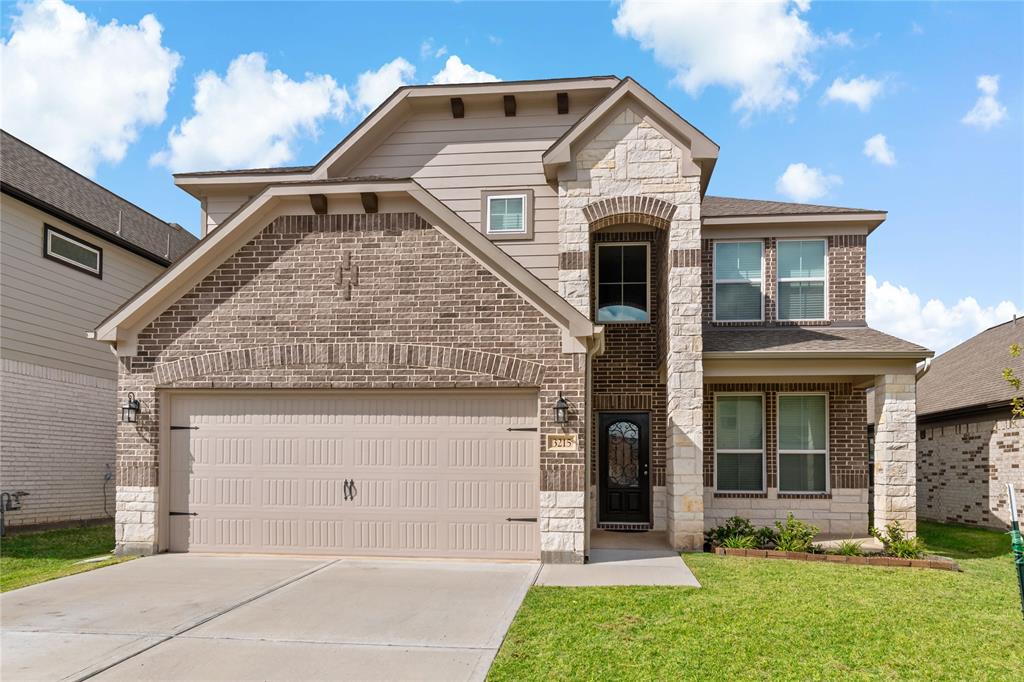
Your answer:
[558,104,703,549]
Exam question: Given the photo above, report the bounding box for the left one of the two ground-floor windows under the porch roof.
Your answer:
[715,394,765,493]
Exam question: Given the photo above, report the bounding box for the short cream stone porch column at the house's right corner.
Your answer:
[874,369,918,536]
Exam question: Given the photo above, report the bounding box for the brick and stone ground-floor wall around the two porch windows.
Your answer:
[703,382,868,536]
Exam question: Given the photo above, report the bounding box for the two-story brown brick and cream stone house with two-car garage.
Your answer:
[96,77,931,562]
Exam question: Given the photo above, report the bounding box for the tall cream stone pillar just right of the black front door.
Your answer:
[664,177,705,550]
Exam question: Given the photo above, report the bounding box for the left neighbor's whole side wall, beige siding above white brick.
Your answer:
[0,196,163,525]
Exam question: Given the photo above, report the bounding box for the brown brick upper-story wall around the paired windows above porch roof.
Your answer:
[700,235,867,327]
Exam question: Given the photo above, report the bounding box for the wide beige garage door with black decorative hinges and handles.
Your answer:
[168,392,540,559]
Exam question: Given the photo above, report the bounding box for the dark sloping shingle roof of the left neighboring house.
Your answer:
[0,131,197,262]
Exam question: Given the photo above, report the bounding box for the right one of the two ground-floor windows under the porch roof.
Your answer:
[778,393,828,493]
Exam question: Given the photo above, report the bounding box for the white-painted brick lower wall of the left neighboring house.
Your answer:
[0,358,118,525]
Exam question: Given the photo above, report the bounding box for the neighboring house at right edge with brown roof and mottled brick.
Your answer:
[918,317,1024,528]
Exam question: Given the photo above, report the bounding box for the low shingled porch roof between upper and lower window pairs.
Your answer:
[703,326,931,358]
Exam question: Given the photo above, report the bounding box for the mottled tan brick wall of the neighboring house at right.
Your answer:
[918,410,1024,530]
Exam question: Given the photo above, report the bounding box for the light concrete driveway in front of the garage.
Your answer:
[0,555,540,680]
